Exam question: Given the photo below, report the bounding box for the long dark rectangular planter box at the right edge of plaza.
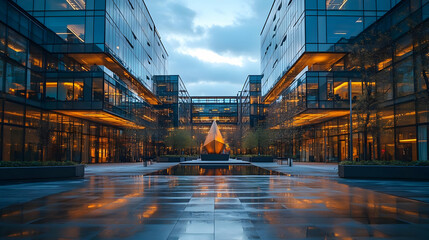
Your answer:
[338,165,429,180]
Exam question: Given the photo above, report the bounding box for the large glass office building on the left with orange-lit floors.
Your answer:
[0,0,168,163]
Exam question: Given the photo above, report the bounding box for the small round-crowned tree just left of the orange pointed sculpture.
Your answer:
[165,129,196,154]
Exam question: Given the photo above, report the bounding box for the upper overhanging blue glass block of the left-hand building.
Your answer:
[15,0,168,96]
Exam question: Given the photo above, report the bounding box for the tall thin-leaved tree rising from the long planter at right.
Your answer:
[349,26,393,160]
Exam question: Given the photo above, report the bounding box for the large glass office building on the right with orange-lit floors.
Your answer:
[261,0,429,161]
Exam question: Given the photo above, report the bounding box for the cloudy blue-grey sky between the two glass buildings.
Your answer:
[145,0,272,96]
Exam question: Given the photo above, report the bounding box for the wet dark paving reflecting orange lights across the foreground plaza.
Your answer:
[0,165,429,240]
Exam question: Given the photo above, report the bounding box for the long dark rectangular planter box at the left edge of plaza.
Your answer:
[0,165,85,180]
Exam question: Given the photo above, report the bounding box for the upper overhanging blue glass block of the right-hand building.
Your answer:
[261,0,399,97]
